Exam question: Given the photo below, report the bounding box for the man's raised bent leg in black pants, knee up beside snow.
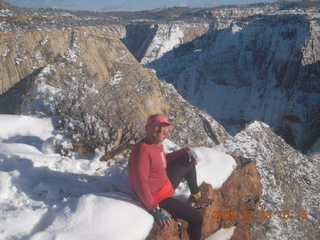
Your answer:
[167,154,200,194]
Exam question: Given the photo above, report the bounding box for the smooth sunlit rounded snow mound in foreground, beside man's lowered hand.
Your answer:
[32,194,153,240]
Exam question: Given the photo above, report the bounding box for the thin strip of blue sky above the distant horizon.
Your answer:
[4,0,286,11]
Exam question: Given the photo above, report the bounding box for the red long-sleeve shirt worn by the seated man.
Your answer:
[128,139,188,209]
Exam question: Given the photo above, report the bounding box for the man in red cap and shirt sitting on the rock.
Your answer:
[128,114,213,240]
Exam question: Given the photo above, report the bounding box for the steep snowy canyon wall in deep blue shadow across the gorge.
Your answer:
[125,9,320,151]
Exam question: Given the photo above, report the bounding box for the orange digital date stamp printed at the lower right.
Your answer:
[212,210,308,220]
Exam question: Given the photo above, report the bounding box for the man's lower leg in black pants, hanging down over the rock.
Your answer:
[159,197,203,240]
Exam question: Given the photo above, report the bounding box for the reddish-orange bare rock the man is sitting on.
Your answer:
[147,156,266,240]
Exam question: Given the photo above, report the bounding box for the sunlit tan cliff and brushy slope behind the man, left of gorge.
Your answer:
[0,25,229,158]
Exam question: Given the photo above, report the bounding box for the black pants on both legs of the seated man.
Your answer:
[159,155,203,240]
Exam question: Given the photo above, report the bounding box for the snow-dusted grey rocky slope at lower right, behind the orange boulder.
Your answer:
[220,122,320,240]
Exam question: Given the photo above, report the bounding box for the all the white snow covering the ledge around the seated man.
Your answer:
[0,115,235,240]
